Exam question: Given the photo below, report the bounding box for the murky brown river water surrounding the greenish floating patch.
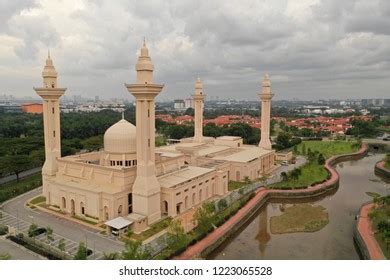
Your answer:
[208,154,390,260]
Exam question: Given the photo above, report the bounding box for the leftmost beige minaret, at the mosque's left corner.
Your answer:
[34,52,66,203]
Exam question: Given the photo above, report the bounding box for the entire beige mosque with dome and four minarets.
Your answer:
[34,42,275,232]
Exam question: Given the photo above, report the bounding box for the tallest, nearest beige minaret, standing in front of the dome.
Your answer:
[125,40,164,224]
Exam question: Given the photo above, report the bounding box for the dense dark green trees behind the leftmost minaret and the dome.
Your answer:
[0,109,135,177]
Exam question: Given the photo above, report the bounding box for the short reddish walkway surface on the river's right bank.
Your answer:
[358,203,385,260]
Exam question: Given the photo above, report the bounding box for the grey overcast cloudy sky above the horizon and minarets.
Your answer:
[0,0,390,100]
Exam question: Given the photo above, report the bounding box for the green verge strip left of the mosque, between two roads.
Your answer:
[0,173,42,202]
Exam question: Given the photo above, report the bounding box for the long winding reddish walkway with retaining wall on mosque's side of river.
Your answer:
[177,144,367,259]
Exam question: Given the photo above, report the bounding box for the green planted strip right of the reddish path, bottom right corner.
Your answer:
[369,196,390,259]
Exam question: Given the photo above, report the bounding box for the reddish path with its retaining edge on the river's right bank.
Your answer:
[354,203,385,260]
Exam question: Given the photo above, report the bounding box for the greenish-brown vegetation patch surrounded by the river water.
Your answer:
[270,203,329,234]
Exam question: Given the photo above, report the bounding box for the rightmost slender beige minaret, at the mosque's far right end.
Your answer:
[259,74,274,150]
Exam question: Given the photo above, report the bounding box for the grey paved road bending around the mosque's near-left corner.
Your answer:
[0,188,124,258]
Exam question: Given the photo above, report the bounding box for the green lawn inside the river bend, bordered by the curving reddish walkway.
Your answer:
[269,162,328,189]
